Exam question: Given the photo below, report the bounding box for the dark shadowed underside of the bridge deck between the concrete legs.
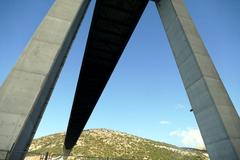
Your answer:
[64,0,148,149]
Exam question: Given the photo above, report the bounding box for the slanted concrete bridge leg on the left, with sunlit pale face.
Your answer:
[0,0,90,160]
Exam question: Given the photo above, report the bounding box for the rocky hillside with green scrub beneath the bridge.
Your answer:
[29,129,208,160]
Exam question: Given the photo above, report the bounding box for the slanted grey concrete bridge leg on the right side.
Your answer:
[156,0,240,160]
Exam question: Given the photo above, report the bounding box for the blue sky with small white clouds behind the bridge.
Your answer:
[0,0,240,147]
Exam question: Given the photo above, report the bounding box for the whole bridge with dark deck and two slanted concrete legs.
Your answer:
[0,0,240,160]
